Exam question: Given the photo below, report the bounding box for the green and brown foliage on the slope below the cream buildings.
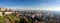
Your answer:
[0,15,33,23]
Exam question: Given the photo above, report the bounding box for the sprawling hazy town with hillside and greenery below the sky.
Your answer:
[0,8,60,23]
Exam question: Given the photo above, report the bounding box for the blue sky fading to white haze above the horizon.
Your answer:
[0,0,60,10]
